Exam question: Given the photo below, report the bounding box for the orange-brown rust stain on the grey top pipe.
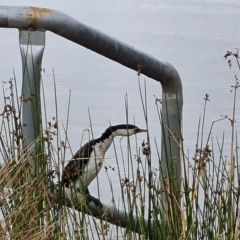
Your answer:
[26,7,51,31]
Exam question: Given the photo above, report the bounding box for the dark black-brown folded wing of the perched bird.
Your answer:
[62,140,94,187]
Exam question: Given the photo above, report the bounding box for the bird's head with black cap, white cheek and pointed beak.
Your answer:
[104,124,147,137]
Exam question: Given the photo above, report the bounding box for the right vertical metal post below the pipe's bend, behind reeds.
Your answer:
[161,81,183,226]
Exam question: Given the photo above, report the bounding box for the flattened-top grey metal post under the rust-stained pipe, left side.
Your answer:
[19,30,45,146]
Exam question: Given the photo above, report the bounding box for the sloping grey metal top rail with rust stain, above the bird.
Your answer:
[0,6,182,93]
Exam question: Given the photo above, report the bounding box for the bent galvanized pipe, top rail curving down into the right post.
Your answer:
[0,6,183,227]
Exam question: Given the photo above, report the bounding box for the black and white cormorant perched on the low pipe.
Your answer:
[62,124,147,207]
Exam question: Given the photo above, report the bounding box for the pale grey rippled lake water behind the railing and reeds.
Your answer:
[0,0,240,225]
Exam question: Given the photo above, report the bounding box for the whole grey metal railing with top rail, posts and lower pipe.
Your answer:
[0,6,183,234]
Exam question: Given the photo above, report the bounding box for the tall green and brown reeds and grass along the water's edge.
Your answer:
[0,51,240,240]
